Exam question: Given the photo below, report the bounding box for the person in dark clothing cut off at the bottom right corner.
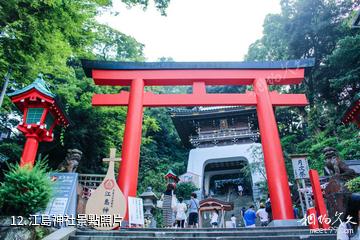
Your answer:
[336,194,360,240]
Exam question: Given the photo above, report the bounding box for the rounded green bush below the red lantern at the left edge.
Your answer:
[0,161,51,216]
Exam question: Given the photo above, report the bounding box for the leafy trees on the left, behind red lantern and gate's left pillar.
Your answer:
[0,0,185,197]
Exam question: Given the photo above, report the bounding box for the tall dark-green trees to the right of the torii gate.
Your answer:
[246,0,360,176]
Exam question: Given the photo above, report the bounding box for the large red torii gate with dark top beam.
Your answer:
[82,59,314,220]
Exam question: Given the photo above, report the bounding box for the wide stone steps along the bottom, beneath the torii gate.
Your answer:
[69,227,336,240]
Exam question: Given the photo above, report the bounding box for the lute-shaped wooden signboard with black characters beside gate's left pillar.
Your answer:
[85,148,126,230]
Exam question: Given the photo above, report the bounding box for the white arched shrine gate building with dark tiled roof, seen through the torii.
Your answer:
[170,106,265,200]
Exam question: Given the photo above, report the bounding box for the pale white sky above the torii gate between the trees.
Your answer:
[98,0,280,61]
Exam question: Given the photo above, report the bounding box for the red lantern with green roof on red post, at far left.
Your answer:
[7,74,69,168]
